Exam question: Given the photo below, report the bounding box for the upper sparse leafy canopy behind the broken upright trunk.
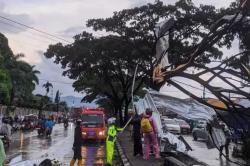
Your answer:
[87,0,222,67]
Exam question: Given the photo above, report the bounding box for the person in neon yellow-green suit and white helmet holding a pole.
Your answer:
[106,118,123,165]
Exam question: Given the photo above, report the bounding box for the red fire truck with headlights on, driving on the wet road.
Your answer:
[81,108,107,141]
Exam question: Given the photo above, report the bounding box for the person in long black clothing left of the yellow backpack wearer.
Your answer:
[131,113,143,156]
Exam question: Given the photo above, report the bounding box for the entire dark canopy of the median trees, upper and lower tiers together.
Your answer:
[45,0,248,120]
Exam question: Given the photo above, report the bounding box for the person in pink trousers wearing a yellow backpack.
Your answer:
[141,109,160,160]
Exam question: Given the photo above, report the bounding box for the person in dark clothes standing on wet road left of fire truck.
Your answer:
[70,119,82,166]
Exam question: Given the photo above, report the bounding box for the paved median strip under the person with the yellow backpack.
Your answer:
[118,130,164,166]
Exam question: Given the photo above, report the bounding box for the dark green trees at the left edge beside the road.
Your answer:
[0,33,40,106]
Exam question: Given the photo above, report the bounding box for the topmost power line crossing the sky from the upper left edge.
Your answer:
[0,15,72,44]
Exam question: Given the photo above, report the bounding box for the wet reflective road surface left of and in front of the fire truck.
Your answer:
[6,124,105,166]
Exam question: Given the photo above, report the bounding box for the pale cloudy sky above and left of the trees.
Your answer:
[0,0,236,96]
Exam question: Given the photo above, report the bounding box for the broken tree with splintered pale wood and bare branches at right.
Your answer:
[154,0,250,163]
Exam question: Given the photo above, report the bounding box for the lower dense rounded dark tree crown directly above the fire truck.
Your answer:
[45,33,146,123]
